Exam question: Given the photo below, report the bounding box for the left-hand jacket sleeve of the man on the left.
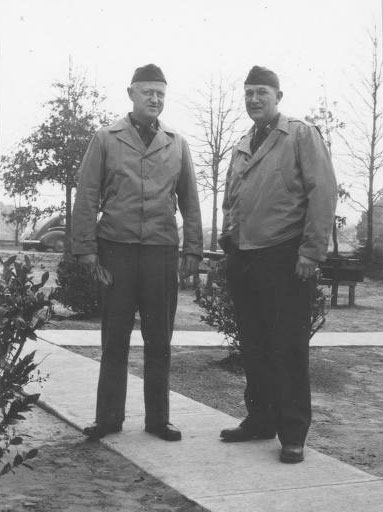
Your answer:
[72,132,105,255]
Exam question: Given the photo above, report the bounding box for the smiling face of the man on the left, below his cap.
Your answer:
[128,82,166,124]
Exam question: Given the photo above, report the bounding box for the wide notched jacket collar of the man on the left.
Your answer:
[108,116,176,156]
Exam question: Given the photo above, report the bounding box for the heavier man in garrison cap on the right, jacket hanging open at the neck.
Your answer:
[220,66,337,463]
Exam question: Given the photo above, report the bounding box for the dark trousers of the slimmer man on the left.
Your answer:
[96,239,178,426]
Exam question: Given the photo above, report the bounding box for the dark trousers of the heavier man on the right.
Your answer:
[227,240,313,446]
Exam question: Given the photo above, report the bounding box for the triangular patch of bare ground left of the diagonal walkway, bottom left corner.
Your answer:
[0,407,205,512]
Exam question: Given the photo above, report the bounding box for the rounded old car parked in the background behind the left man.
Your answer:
[21,214,65,252]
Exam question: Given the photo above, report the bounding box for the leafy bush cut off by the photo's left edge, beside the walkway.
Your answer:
[0,256,52,476]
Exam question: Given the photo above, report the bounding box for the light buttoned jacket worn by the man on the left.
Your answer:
[72,117,202,256]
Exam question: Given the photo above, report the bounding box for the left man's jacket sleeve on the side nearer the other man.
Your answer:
[176,138,203,258]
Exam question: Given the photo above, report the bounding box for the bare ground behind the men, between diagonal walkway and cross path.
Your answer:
[71,347,383,477]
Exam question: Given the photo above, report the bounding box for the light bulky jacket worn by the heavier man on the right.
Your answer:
[222,115,337,261]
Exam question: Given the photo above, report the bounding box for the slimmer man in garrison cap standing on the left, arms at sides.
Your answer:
[72,64,202,441]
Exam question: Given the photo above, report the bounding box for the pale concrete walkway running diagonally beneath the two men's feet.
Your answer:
[26,331,383,512]
